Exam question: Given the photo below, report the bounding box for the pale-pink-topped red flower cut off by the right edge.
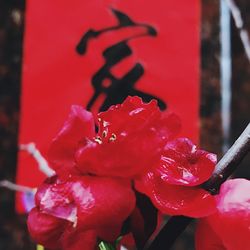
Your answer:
[198,179,250,250]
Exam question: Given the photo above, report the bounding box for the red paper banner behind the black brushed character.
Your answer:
[17,0,200,211]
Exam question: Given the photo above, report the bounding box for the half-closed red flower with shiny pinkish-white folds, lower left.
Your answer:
[28,176,135,249]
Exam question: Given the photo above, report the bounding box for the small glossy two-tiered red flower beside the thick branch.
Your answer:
[136,138,216,217]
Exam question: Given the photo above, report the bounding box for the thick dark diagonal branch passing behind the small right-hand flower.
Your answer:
[145,123,250,250]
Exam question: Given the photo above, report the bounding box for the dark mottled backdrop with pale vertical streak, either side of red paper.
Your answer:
[0,0,250,250]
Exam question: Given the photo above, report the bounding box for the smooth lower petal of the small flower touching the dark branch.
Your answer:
[136,173,216,218]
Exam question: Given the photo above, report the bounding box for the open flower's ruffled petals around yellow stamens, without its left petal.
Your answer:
[76,97,180,178]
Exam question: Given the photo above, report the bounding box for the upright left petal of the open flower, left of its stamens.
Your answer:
[48,105,95,174]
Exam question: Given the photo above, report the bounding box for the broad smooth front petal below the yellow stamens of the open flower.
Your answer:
[76,131,161,178]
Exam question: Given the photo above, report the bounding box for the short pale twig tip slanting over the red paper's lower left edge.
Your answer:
[19,142,55,176]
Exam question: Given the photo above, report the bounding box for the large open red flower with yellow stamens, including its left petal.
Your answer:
[49,97,180,178]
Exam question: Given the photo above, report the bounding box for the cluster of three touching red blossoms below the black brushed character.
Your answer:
[28,97,216,250]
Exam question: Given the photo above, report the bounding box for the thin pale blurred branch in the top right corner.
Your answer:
[225,0,250,61]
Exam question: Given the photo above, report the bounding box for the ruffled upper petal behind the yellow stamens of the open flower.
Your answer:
[98,96,181,143]
